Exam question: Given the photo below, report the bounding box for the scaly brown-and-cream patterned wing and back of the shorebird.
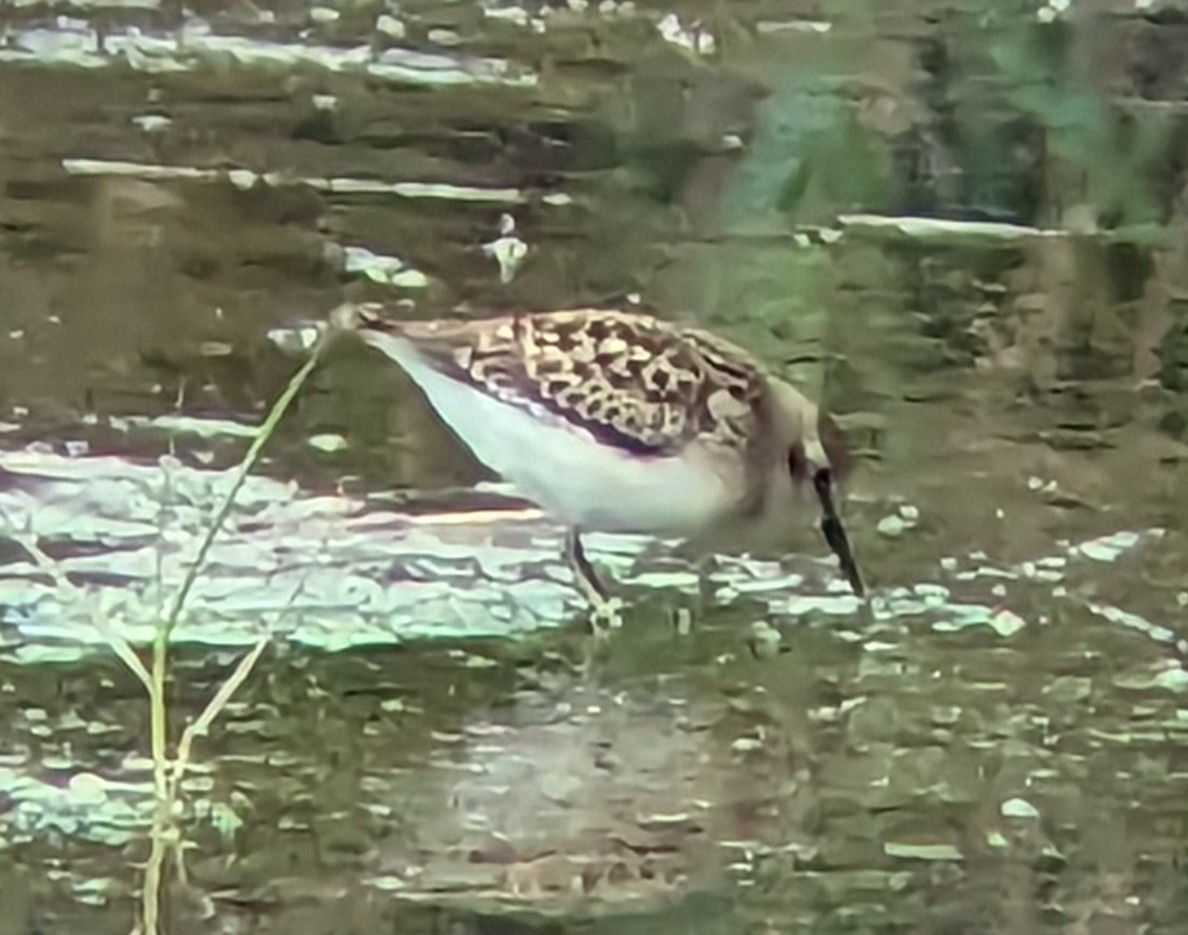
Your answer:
[389,309,764,455]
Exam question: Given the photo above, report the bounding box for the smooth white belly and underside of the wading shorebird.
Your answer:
[365,333,740,537]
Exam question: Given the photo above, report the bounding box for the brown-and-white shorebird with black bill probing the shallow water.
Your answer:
[330,303,864,630]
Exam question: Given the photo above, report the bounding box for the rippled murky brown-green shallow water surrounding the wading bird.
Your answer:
[0,0,1188,935]
